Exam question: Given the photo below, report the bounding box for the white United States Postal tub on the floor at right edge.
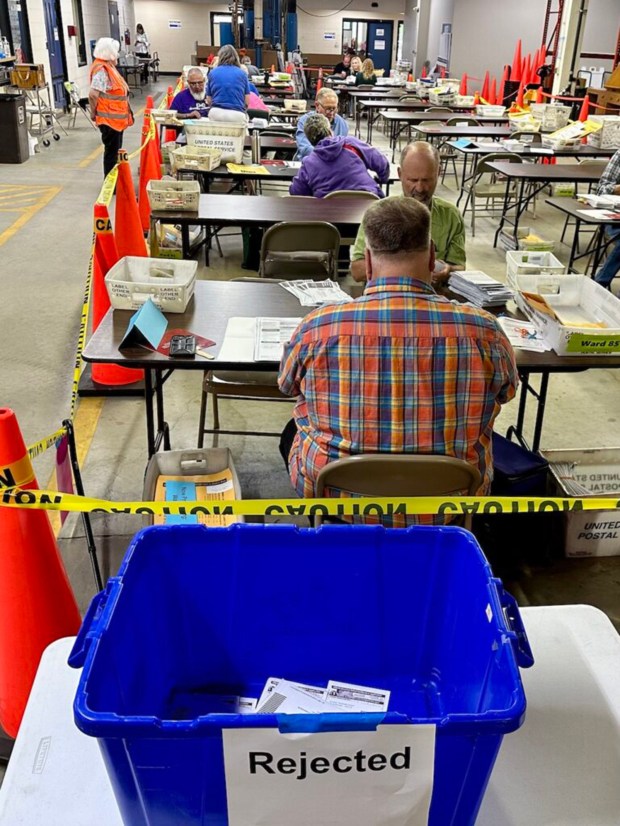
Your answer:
[541,448,620,557]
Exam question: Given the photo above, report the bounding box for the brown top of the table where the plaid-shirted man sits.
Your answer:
[84,280,620,373]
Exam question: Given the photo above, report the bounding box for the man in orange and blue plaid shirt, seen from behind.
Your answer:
[279,197,518,506]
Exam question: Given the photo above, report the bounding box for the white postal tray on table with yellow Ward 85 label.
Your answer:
[514,273,620,356]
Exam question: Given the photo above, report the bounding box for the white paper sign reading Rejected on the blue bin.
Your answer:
[222,725,435,826]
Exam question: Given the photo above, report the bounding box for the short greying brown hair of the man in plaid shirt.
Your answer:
[362,196,431,256]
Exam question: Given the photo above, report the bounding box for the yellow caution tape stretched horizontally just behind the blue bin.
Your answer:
[0,490,620,517]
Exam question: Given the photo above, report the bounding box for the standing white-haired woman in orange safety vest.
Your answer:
[88,37,133,177]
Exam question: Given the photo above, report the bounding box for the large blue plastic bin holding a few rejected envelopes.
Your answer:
[70,525,532,826]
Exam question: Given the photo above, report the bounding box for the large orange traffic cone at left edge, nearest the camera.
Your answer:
[0,407,81,737]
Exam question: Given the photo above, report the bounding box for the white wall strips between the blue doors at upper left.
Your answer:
[28,0,135,99]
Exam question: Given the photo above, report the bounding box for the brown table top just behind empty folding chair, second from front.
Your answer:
[153,193,371,228]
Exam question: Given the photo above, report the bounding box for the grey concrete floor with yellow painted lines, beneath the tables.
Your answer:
[0,79,620,768]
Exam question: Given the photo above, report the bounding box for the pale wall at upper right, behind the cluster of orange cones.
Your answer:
[450,0,620,87]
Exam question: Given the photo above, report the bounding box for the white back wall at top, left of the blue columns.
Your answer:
[135,0,228,73]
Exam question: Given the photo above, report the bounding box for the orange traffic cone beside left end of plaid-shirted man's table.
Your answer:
[90,204,144,386]
